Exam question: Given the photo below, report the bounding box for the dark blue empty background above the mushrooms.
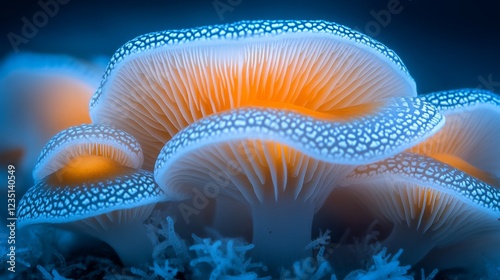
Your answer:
[0,0,500,93]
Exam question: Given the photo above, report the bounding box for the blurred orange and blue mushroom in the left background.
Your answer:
[0,53,103,188]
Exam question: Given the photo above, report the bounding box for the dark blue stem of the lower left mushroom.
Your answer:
[102,223,153,267]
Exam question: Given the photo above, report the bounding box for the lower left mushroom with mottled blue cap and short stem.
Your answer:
[17,165,166,266]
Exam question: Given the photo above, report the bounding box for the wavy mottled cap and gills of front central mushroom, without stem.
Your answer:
[155,98,444,203]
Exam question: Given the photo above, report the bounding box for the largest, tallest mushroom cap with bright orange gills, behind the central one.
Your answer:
[90,20,416,169]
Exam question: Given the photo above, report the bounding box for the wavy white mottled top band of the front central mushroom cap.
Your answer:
[155,98,444,176]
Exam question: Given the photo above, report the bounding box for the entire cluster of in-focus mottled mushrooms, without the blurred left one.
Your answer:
[19,20,500,274]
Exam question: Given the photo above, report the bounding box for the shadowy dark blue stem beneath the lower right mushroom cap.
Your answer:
[381,224,435,265]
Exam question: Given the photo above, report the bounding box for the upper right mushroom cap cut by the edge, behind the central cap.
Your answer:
[409,88,500,178]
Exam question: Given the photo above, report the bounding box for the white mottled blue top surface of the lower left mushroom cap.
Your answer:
[17,170,164,226]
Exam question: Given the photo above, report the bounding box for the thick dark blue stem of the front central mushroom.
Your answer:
[252,201,314,273]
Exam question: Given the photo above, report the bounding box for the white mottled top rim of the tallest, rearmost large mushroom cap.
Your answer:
[90,20,409,109]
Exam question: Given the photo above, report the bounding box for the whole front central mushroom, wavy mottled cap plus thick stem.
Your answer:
[155,98,443,270]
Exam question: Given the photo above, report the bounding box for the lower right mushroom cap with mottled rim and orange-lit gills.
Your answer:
[338,153,500,247]
